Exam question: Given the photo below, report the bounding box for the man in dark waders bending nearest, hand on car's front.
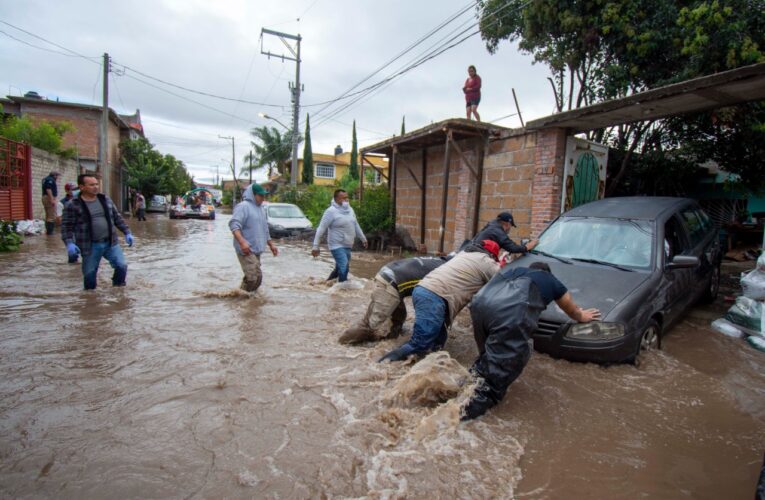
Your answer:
[461,262,600,420]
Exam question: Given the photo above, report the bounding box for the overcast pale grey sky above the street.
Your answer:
[0,0,554,181]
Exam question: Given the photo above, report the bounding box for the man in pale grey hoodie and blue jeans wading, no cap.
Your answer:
[311,189,367,283]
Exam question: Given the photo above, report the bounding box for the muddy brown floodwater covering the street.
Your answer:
[0,215,765,499]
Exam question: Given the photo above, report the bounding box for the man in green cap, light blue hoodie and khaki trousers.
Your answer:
[228,183,279,292]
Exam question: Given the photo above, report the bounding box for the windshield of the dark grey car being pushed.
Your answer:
[534,217,653,268]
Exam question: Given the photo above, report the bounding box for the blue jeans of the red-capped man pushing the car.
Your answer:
[402,286,449,353]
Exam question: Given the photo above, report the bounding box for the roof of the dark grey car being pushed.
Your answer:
[563,196,693,220]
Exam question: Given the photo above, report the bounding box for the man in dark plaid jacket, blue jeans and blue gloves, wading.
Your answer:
[61,174,133,290]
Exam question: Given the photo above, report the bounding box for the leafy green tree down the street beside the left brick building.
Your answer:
[120,137,193,200]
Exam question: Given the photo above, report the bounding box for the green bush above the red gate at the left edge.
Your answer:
[0,113,77,158]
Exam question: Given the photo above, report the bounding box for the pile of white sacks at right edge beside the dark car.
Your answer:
[712,254,765,351]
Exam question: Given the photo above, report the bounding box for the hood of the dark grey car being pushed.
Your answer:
[508,255,650,321]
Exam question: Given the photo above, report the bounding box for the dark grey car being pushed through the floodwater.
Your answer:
[509,197,722,363]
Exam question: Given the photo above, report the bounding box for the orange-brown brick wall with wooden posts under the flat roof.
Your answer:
[396,129,566,253]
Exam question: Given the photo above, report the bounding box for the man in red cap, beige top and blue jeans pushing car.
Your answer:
[379,240,499,362]
